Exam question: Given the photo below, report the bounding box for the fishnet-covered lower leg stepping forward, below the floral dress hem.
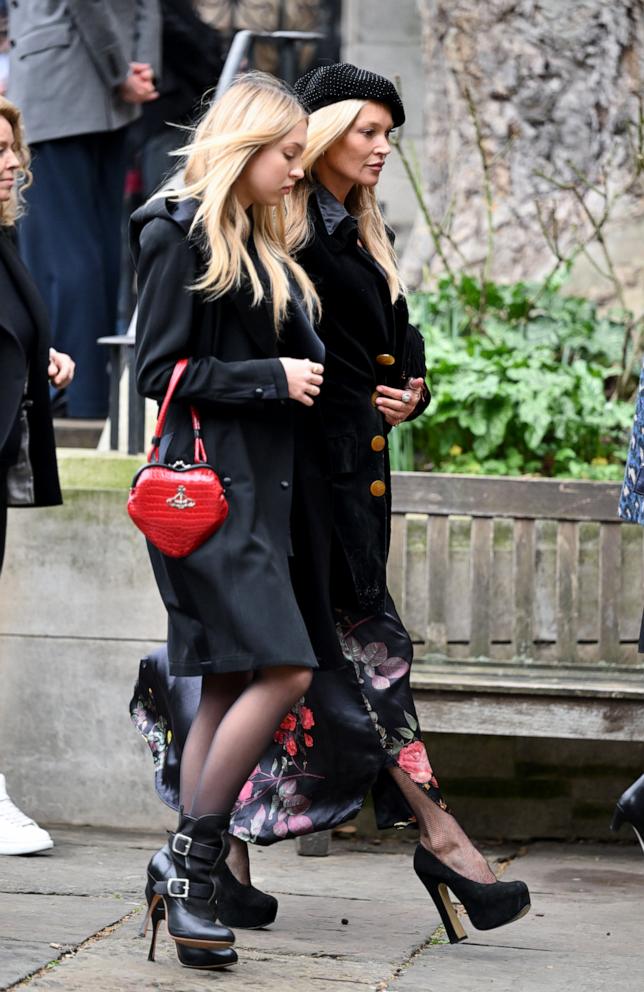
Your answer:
[388,768,496,883]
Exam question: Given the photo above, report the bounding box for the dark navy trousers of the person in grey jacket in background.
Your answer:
[19,128,127,418]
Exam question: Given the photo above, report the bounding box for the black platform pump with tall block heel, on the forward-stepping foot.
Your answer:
[414,844,530,944]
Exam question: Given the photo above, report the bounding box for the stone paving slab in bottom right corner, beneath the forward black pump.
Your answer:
[385,844,644,992]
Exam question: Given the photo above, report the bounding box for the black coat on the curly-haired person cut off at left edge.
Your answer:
[0,227,62,506]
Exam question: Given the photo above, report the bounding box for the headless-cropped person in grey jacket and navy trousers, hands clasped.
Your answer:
[8,0,161,418]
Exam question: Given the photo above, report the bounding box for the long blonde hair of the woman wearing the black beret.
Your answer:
[286,100,404,302]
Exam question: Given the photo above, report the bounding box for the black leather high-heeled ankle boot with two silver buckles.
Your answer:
[143,815,235,960]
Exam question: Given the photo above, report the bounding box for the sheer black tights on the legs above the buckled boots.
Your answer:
[181,665,311,817]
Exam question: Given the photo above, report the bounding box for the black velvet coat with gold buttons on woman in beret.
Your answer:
[296,187,430,612]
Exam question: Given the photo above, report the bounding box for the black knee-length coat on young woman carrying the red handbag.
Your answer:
[131,200,323,675]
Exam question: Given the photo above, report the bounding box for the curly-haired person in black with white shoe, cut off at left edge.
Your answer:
[0,96,74,854]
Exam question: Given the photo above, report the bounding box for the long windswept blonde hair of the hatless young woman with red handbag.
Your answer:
[173,72,320,330]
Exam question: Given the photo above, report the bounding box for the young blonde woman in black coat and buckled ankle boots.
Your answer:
[132,73,324,967]
